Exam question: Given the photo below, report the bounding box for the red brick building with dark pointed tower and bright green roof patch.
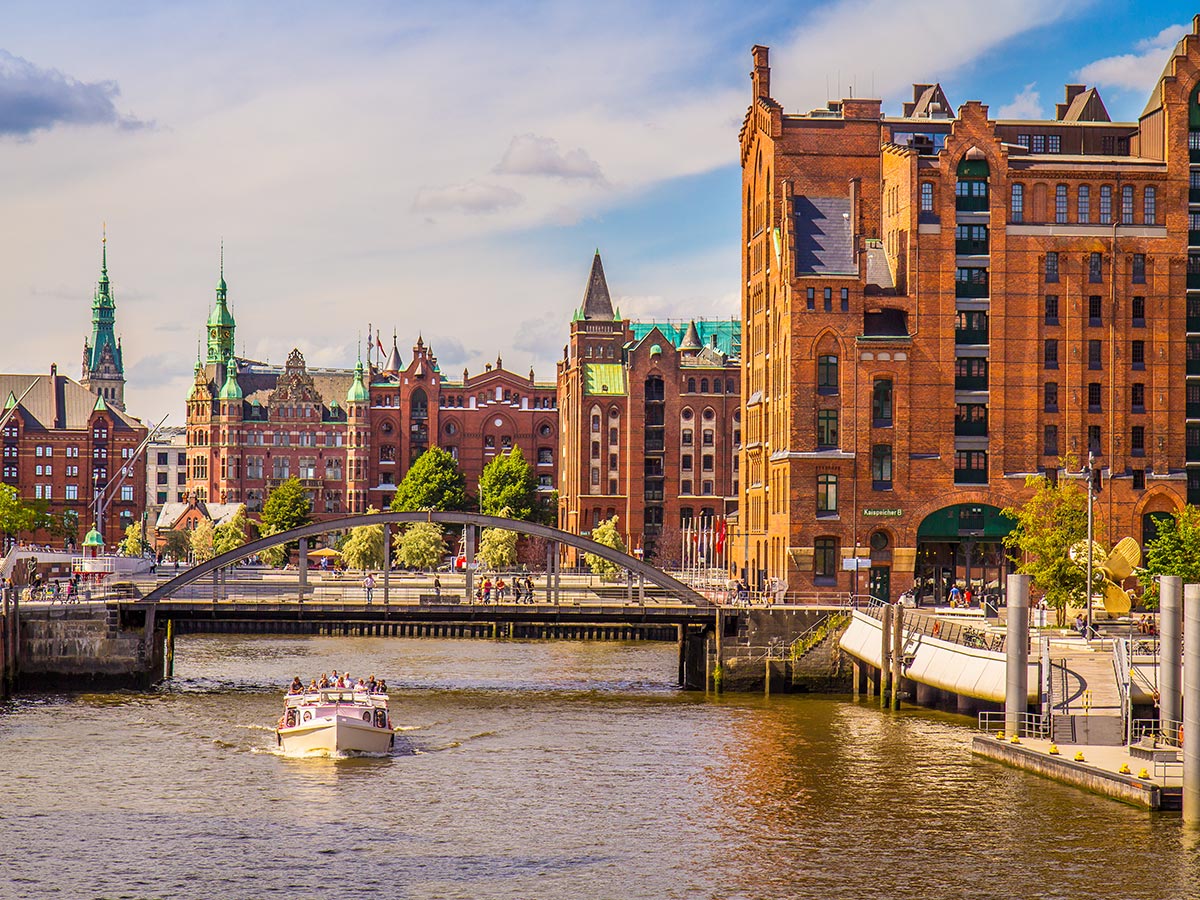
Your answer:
[558,253,742,564]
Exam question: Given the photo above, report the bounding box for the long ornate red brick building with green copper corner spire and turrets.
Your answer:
[187,267,558,518]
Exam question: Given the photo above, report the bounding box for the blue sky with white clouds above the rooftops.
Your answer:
[0,0,1200,425]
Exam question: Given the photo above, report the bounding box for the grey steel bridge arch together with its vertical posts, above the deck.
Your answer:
[143,511,713,610]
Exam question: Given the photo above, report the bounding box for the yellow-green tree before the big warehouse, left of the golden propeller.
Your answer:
[1002,475,1098,628]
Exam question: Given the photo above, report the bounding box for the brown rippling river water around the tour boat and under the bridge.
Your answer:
[0,636,1200,900]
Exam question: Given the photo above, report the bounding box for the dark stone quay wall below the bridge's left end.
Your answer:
[16,604,166,689]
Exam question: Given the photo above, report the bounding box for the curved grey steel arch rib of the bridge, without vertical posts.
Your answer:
[145,511,712,606]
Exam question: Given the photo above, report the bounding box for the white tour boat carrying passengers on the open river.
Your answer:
[275,688,394,756]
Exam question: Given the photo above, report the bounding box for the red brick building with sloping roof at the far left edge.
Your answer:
[0,366,146,548]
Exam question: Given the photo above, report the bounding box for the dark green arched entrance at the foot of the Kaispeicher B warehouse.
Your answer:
[913,503,1016,605]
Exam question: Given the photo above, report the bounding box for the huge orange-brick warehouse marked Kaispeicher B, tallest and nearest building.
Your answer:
[733,28,1200,596]
